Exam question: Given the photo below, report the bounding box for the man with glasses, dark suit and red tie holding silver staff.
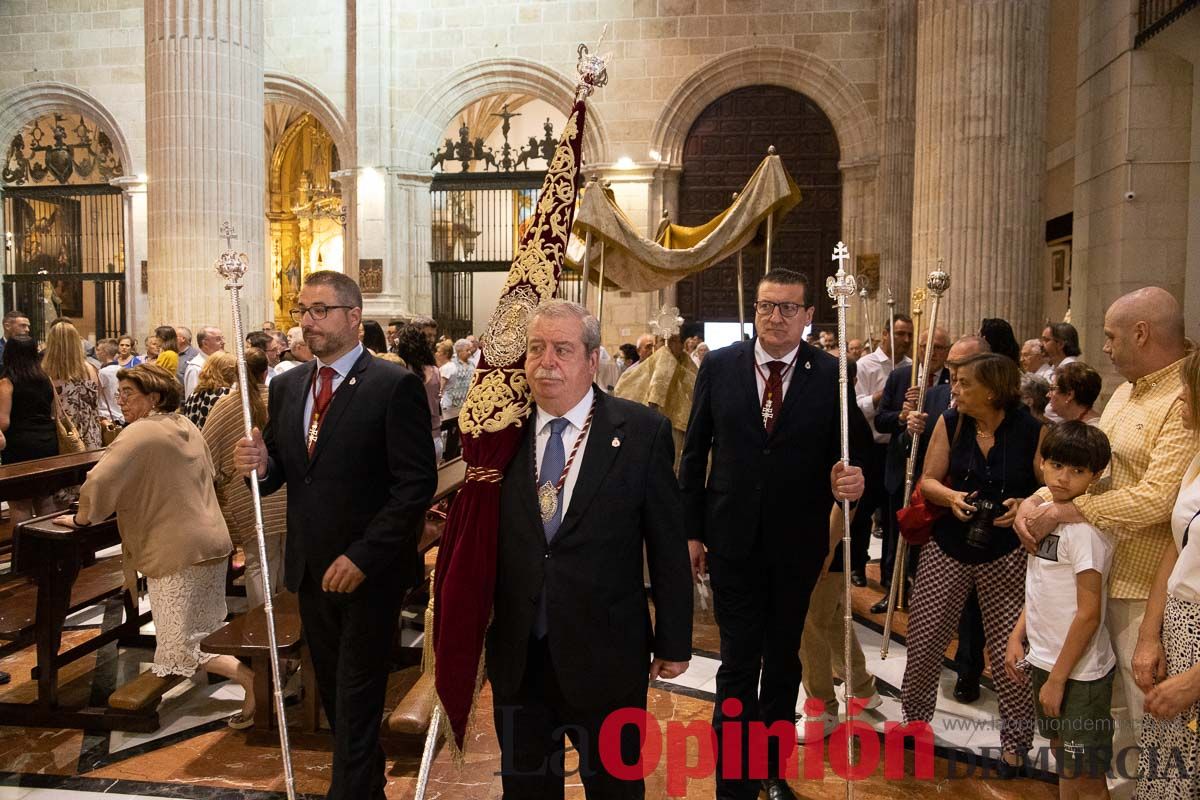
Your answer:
[679,270,871,800]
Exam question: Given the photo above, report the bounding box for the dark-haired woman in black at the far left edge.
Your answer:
[0,336,59,524]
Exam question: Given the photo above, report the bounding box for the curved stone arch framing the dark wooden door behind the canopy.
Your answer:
[650,47,878,167]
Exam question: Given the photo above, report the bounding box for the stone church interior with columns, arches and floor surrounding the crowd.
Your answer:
[0,0,1200,800]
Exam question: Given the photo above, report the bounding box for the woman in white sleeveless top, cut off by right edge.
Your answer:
[1133,353,1200,800]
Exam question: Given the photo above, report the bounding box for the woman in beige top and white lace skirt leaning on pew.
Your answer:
[55,363,254,729]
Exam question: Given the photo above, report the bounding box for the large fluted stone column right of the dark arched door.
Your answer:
[912,0,1046,339]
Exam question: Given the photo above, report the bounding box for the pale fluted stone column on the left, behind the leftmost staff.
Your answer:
[145,0,270,331]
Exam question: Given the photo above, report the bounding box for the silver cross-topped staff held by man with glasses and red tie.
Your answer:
[826,242,859,800]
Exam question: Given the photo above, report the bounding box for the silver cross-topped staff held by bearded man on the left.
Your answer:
[215,222,296,800]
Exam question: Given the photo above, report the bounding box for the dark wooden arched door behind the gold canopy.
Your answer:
[676,85,841,327]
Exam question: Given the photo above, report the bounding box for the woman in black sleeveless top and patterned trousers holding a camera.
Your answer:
[901,353,1043,777]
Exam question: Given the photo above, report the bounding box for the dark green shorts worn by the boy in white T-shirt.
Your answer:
[1031,664,1116,777]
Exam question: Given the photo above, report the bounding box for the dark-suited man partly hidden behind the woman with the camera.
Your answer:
[871,327,950,614]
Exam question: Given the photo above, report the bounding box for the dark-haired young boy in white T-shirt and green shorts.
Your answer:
[1004,421,1116,800]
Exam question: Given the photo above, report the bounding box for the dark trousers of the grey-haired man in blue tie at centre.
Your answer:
[493,638,653,800]
